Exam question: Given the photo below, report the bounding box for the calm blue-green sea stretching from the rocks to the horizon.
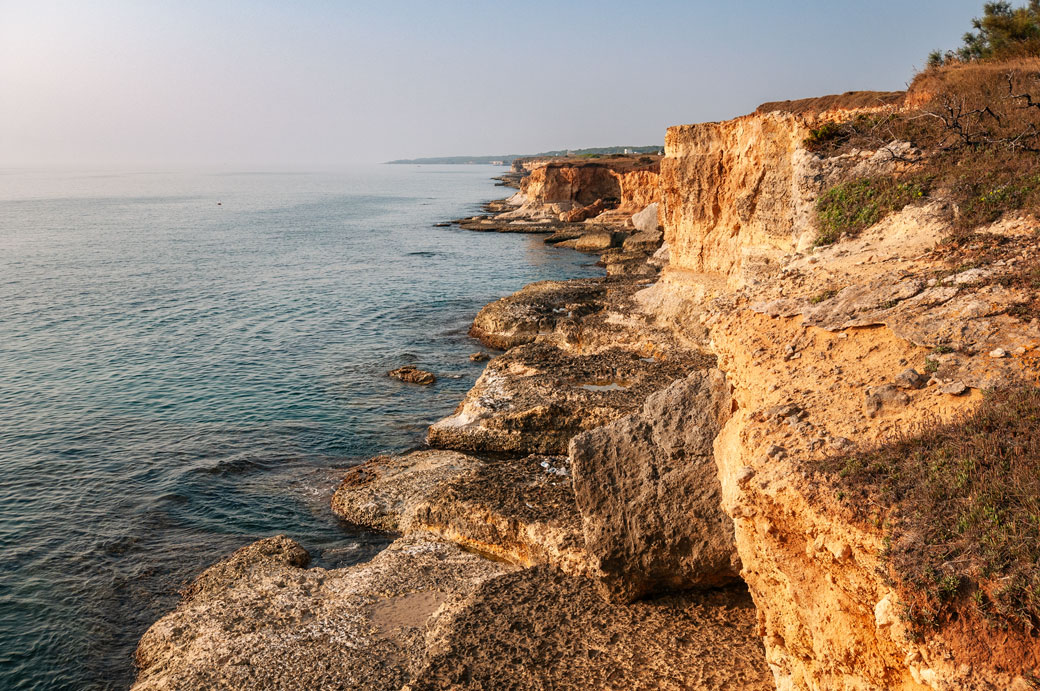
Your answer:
[0,165,599,689]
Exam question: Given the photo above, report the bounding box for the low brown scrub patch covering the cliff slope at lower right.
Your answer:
[821,386,1040,633]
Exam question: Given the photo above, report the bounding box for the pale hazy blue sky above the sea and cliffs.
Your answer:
[0,0,985,169]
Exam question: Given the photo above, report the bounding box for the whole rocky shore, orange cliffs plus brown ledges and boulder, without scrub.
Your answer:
[135,99,1040,691]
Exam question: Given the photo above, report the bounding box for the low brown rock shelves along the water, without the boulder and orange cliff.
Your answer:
[134,159,770,689]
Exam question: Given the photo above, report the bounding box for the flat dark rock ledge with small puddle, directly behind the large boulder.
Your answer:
[426,342,713,455]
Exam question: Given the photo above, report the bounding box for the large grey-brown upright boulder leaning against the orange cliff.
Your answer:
[570,369,740,602]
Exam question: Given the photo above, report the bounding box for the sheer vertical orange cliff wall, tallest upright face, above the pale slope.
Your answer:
[660,113,820,287]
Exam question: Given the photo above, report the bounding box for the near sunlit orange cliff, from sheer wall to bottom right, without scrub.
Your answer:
[657,113,1040,691]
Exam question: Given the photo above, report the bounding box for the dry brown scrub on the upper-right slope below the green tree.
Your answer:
[805,58,1040,244]
